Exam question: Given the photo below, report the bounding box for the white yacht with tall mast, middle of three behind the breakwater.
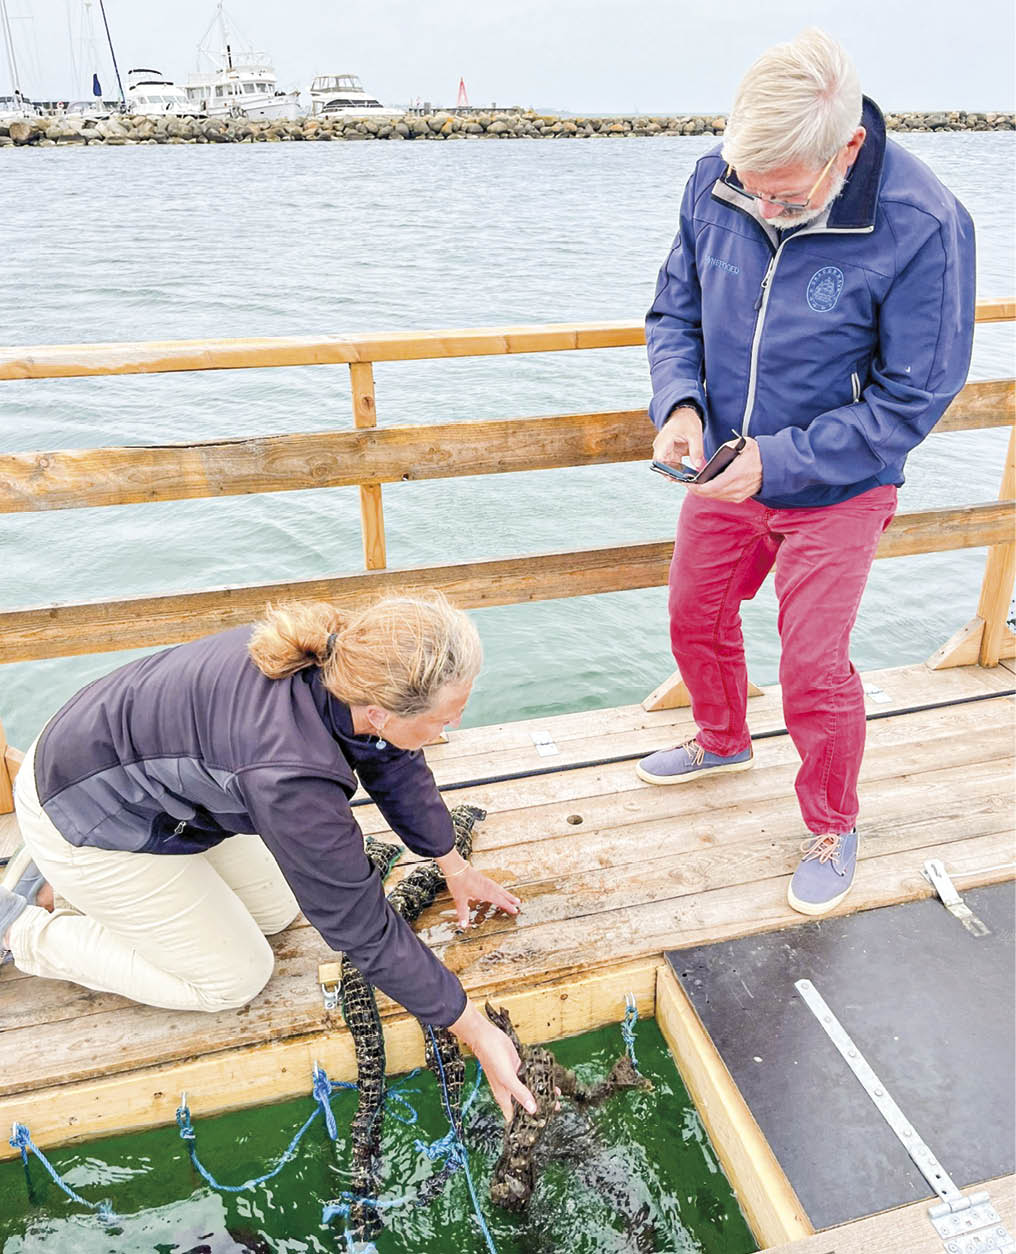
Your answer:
[186,4,301,119]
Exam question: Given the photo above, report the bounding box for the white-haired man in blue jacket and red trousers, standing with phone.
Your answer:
[637,30,975,914]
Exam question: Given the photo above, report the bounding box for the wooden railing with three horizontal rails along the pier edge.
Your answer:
[0,301,1016,666]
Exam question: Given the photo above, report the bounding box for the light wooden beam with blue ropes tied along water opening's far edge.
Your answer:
[0,956,660,1160]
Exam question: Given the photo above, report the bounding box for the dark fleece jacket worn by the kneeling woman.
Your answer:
[35,627,465,1026]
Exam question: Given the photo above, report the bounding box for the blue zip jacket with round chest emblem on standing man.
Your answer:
[646,98,975,508]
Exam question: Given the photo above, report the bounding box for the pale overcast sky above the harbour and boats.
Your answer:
[0,0,1016,114]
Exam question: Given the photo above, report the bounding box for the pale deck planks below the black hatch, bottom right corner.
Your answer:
[764,1175,1016,1254]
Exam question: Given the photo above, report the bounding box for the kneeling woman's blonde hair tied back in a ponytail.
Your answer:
[248,592,483,717]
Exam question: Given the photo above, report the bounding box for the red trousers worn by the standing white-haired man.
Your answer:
[670,487,896,833]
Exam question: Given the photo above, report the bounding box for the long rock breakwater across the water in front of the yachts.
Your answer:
[0,109,1016,148]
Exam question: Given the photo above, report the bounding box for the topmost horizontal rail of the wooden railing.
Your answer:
[0,301,998,380]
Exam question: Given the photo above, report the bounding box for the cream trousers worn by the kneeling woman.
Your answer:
[10,745,299,1011]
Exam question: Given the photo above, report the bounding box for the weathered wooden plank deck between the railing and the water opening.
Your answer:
[0,663,1016,1152]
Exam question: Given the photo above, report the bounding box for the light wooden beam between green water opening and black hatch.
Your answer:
[656,968,815,1246]
